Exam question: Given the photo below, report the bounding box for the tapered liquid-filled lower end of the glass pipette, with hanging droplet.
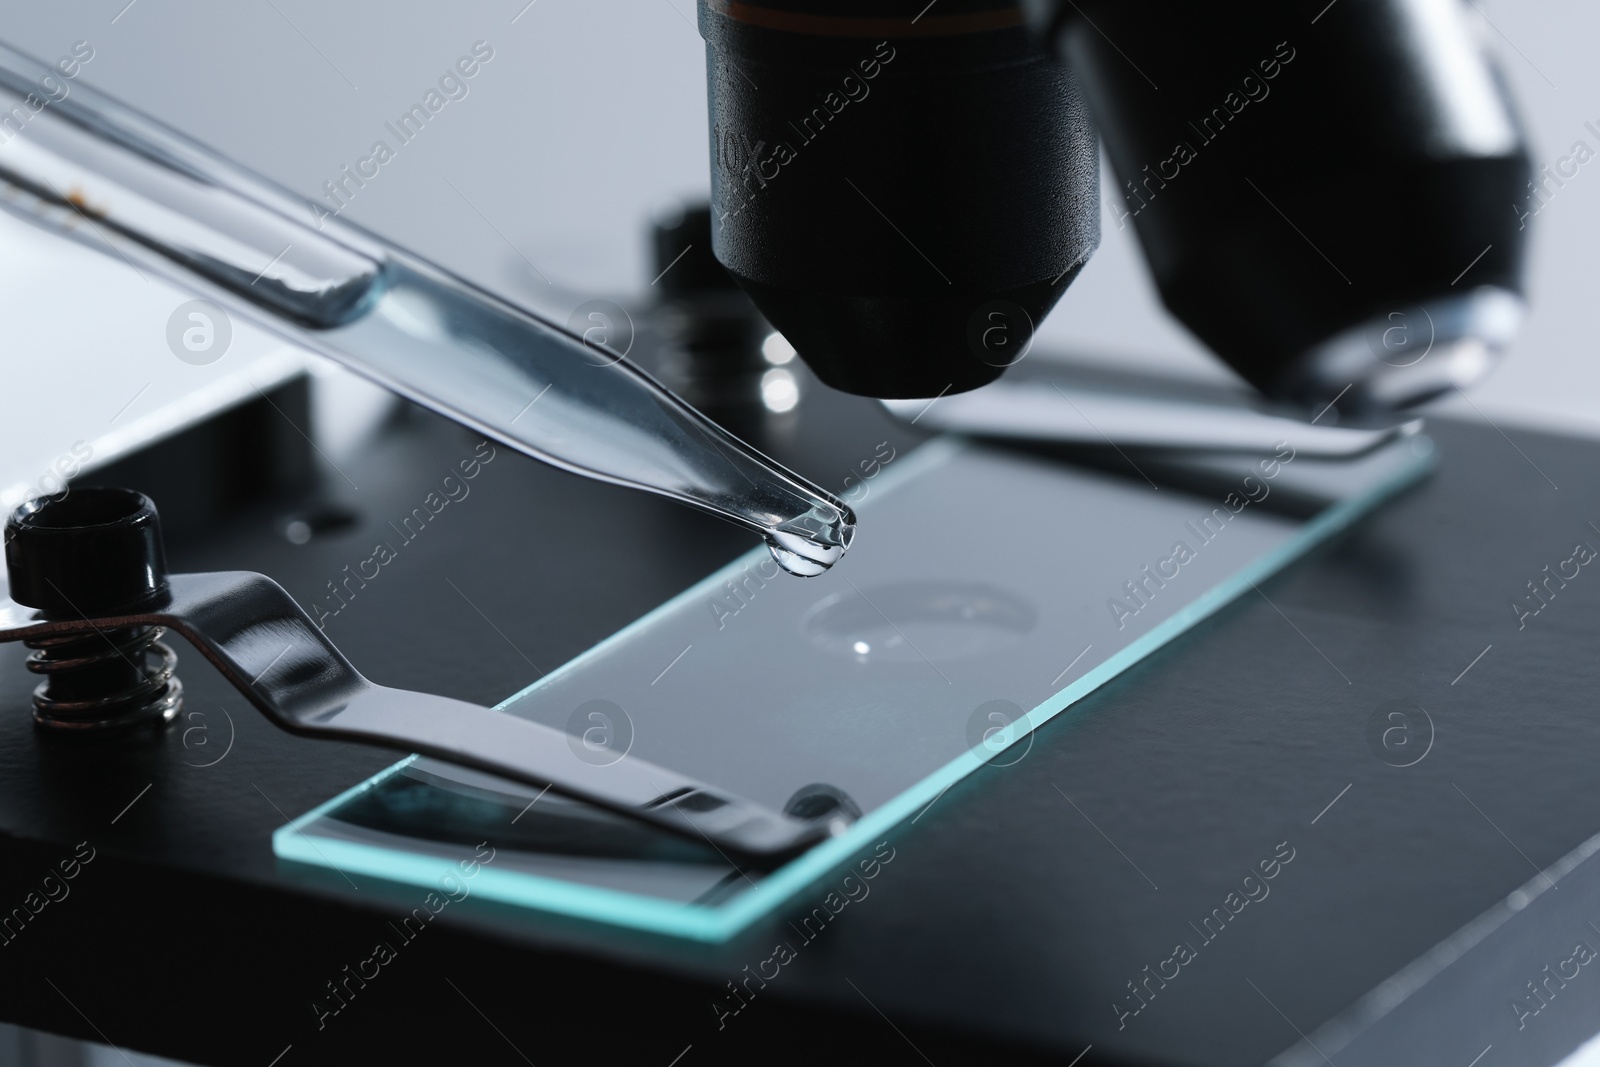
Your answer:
[314,262,856,577]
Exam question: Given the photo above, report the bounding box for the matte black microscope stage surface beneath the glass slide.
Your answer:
[0,383,1600,1067]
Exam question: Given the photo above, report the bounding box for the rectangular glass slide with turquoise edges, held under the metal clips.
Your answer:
[274,437,1432,942]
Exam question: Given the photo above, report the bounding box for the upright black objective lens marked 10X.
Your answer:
[699,0,1101,397]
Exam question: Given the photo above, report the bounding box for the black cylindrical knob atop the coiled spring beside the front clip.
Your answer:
[5,486,166,617]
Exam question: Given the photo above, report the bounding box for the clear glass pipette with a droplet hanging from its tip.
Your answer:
[0,59,854,576]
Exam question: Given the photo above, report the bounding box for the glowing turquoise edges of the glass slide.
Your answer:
[272,435,1435,942]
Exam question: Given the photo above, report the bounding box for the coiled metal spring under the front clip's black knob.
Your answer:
[24,625,184,731]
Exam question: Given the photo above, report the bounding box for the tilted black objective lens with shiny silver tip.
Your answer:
[1030,0,1531,411]
